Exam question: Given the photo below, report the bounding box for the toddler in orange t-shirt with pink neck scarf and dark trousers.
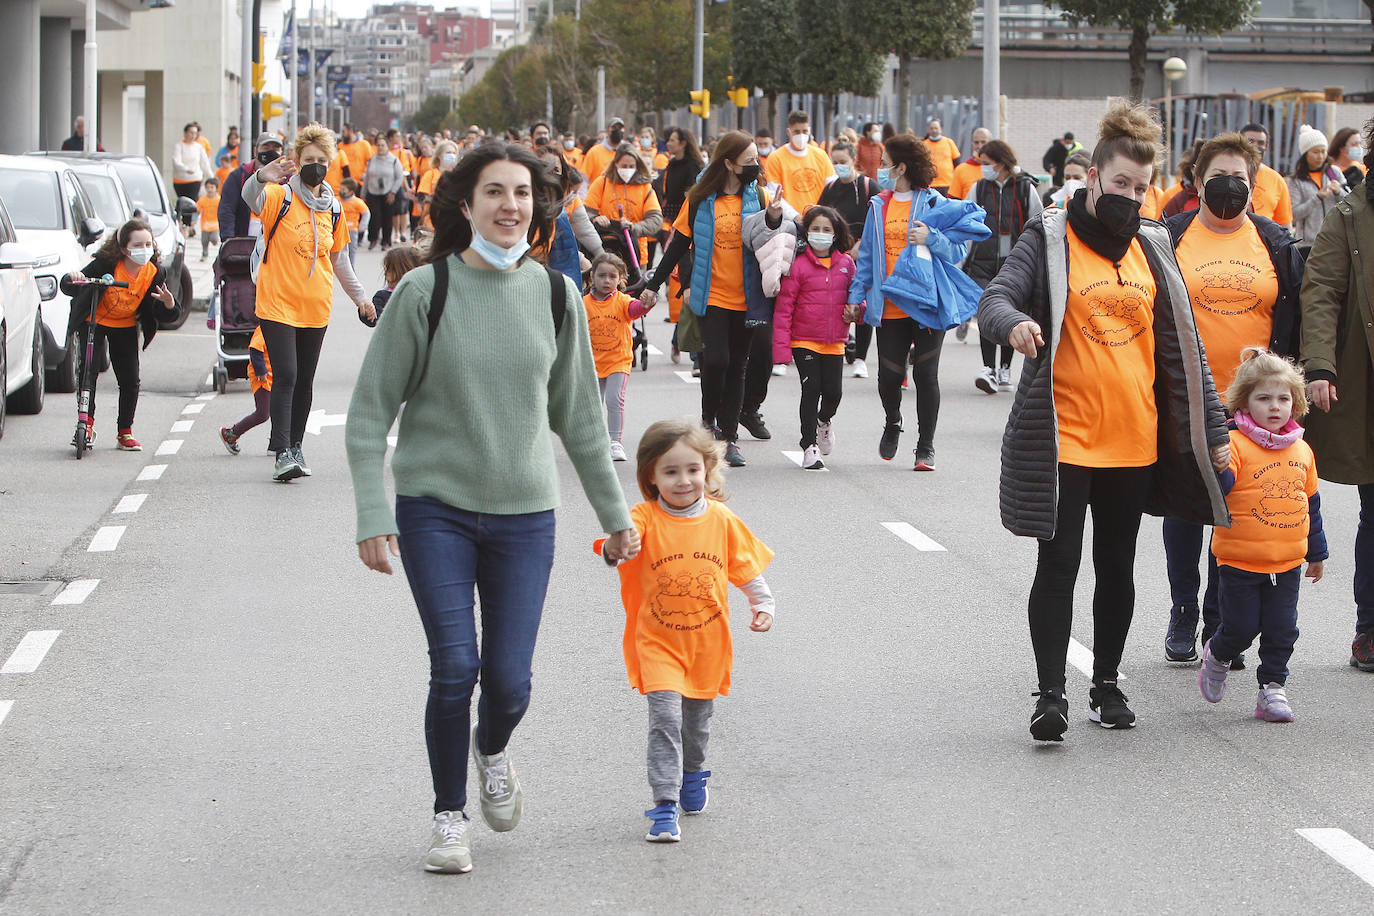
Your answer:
[1198,346,1327,722]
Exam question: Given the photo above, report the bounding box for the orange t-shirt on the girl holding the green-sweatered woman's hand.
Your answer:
[620,500,774,699]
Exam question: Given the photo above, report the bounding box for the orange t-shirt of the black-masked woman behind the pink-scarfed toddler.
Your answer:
[1175,217,1279,404]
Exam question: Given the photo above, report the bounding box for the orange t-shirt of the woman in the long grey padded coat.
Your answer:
[1054,227,1160,467]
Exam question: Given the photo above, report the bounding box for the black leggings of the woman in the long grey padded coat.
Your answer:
[1027,466,1153,691]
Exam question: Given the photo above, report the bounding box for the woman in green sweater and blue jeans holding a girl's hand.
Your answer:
[346,144,639,872]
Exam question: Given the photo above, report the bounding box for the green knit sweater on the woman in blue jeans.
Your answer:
[345,255,632,541]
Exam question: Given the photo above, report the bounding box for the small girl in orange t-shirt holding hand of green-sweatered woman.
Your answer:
[598,419,774,843]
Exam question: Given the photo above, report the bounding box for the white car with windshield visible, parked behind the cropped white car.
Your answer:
[0,155,106,391]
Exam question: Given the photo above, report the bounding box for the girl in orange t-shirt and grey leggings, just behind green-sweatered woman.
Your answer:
[583,251,649,461]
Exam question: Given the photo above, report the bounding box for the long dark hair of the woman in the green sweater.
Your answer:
[427,143,563,264]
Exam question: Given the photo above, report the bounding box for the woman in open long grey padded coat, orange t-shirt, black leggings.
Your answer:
[978,103,1230,742]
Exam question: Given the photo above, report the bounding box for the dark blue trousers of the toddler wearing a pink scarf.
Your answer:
[1212,564,1303,687]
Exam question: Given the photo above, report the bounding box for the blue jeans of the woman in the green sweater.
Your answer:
[396,496,554,812]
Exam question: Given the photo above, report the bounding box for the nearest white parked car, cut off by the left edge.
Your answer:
[0,202,56,437]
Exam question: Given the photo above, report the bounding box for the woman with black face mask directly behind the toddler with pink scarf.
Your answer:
[1164,133,1303,667]
